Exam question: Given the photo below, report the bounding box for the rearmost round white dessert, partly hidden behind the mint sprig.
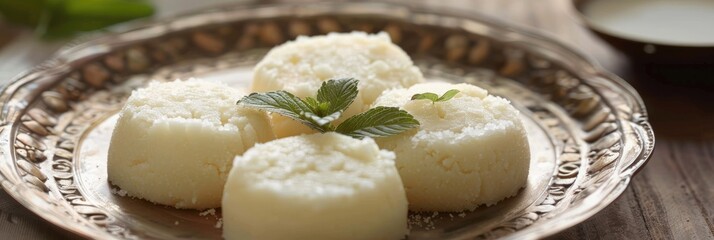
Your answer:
[252,32,424,137]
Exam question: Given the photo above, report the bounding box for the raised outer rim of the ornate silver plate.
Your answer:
[0,2,654,238]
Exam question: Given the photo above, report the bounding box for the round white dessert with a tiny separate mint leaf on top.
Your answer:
[375,83,530,211]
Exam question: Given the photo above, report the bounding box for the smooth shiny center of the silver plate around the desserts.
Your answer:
[74,62,557,239]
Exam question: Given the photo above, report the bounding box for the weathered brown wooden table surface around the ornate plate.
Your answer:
[0,0,714,239]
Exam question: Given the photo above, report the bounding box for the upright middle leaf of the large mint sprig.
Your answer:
[317,78,359,116]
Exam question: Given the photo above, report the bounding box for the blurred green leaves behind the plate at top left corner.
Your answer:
[0,0,154,37]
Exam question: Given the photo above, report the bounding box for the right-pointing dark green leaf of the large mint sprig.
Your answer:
[335,107,419,139]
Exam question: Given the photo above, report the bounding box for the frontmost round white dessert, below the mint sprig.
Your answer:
[222,133,407,240]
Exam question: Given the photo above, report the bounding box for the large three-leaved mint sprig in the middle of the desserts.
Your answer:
[238,78,419,139]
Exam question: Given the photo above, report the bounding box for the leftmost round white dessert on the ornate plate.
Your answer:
[107,80,275,209]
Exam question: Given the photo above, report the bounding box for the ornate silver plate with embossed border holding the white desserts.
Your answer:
[0,2,654,239]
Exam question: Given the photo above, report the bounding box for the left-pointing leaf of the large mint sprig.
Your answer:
[237,91,327,132]
